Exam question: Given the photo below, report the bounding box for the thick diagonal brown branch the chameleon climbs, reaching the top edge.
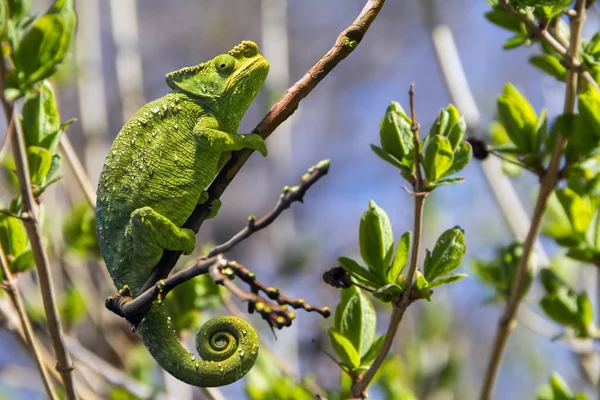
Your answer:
[140,0,385,292]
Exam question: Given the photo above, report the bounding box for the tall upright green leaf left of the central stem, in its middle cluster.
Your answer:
[359,200,394,281]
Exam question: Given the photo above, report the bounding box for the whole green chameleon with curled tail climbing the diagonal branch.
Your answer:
[97,41,269,387]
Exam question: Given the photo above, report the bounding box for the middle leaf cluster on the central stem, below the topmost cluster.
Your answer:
[338,201,466,302]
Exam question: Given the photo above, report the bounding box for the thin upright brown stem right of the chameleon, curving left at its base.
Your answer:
[350,84,427,398]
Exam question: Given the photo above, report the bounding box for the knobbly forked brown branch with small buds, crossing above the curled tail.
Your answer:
[105,160,329,328]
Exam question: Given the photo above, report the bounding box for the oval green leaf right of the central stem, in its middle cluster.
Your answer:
[424,226,467,281]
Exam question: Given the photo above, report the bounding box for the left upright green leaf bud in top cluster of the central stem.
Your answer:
[379,101,414,167]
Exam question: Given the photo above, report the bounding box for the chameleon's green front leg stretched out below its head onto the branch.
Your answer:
[194,116,267,157]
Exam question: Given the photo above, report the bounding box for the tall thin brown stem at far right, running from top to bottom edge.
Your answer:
[480,0,585,400]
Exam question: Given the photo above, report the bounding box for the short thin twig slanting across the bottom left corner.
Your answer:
[0,244,58,400]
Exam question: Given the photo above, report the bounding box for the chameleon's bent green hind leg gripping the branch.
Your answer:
[131,207,196,258]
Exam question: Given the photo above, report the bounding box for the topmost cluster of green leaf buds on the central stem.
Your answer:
[371,102,473,191]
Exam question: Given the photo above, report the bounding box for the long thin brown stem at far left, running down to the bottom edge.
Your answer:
[6,106,76,400]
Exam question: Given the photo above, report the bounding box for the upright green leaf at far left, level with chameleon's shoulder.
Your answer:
[22,80,60,152]
